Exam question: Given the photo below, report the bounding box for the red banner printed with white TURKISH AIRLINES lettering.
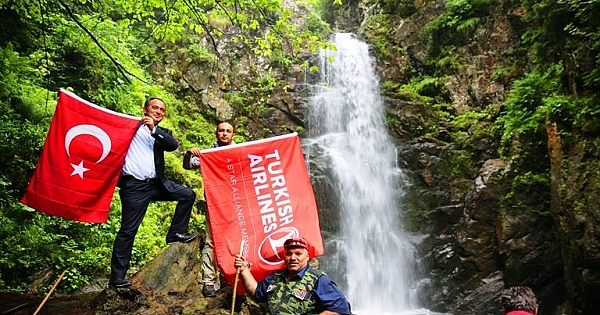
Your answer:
[200,133,323,293]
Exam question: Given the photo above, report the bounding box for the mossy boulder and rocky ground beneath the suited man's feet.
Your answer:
[0,239,251,315]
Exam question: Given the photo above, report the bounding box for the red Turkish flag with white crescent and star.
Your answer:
[21,89,140,223]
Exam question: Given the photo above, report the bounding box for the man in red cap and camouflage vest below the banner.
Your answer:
[234,237,351,315]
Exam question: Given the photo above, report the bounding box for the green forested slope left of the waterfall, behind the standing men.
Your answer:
[0,0,327,293]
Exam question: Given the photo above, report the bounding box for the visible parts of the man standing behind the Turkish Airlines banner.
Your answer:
[183,122,236,301]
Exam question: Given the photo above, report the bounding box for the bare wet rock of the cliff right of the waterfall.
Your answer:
[324,0,600,315]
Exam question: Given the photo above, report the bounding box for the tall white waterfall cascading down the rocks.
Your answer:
[305,34,440,315]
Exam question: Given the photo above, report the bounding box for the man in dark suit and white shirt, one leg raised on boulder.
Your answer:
[108,97,198,288]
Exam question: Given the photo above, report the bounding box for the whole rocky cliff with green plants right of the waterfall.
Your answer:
[324,0,600,314]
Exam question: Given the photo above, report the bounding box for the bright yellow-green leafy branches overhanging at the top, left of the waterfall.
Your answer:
[92,0,332,69]
